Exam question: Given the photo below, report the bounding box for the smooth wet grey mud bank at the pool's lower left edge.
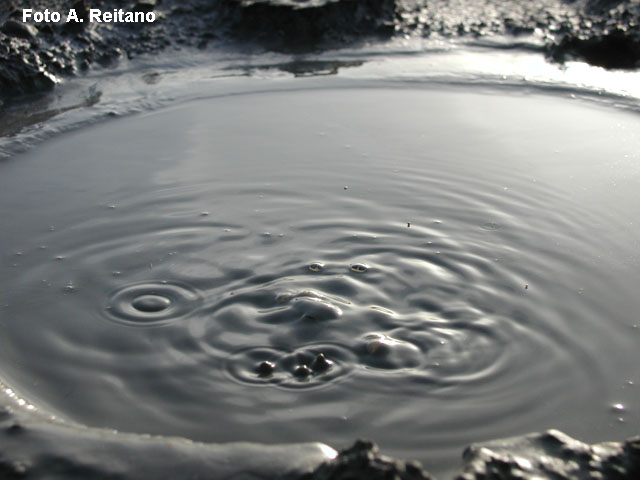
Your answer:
[0,384,336,480]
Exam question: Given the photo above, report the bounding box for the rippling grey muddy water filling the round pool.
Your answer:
[0,79,640,475]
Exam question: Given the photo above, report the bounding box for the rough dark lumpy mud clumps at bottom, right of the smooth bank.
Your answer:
[301,430,640,480]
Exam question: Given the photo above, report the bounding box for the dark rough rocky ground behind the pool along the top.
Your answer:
[0,0,640,100]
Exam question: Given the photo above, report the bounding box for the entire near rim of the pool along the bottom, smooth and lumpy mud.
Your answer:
[0,385,640,480]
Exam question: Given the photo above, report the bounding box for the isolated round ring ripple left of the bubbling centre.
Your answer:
[104,282,200,326]
